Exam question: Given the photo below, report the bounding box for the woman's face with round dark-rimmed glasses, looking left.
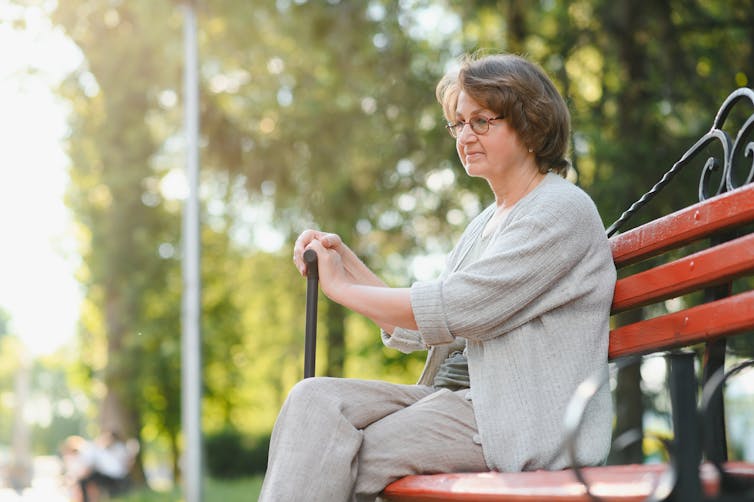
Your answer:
[456,91,528,184]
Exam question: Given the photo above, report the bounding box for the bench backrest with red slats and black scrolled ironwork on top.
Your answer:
[608,88,754,360]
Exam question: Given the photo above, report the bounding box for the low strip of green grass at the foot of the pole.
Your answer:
[110,476,262,502]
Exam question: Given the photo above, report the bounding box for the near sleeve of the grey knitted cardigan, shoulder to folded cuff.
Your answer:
[411,190,612,345]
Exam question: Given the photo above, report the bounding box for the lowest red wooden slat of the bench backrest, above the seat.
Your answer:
[608,291,754,359]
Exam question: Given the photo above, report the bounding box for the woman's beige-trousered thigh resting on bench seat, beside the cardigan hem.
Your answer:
[356,389,487,494]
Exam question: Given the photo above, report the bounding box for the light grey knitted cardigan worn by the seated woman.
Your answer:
[382,174,616,472]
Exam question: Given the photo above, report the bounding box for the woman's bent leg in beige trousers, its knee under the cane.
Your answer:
[260,377,434,501]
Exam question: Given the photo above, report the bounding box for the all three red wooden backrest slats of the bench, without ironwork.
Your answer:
[609,184,754,359]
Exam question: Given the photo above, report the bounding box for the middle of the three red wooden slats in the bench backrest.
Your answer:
[612,234,754,313]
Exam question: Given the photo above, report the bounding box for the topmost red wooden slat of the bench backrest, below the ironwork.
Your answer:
[610,184,754,267]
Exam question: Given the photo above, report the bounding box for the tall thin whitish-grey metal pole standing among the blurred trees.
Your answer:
[181,0,203,502]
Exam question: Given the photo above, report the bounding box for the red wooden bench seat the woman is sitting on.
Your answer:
[383,462,754,502]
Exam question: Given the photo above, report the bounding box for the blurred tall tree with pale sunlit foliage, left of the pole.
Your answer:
[55,1,184,482]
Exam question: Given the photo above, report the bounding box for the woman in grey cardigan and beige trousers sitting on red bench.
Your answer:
[260,55,615,501]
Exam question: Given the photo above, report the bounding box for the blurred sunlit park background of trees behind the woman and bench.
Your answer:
[0,0,754,501]
